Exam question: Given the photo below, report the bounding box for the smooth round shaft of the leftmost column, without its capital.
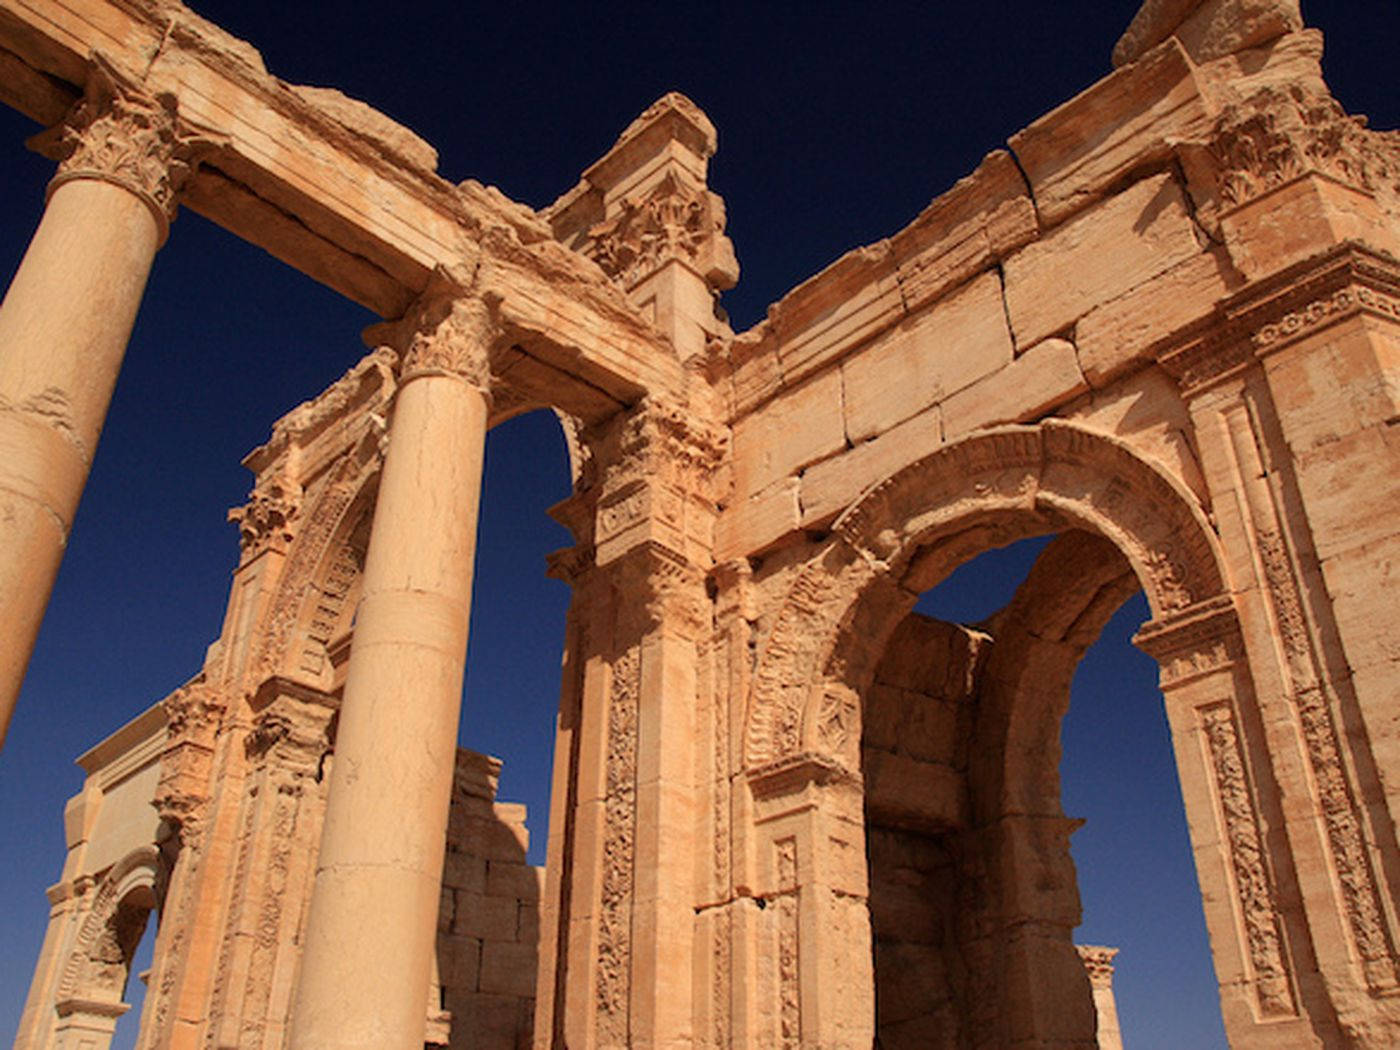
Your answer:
[0,179,164,745]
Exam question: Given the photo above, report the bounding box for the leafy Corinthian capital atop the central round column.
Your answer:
[364,266,501,396]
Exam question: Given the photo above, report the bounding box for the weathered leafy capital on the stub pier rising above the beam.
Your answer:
[584,174,739,291]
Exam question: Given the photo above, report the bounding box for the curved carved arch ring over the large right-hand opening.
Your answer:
[745,420,1228,777]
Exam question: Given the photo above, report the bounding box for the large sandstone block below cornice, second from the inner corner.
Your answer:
[841,273,1014,442]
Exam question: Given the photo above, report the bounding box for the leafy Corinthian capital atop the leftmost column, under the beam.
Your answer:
[29,52,216,244]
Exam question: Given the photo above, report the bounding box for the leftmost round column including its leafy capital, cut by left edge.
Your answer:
[0,57,207,746]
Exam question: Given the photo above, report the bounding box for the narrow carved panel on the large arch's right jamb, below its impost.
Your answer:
[1200,701,1298,1016]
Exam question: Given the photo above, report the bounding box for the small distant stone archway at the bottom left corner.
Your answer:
[53,846,162,1050]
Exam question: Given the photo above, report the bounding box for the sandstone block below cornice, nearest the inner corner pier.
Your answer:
[734,368,846,498]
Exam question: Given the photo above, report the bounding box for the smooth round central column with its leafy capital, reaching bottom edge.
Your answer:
[291,288,493,1050]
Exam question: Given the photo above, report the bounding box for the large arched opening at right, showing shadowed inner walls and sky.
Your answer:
[861,531,1224,1050]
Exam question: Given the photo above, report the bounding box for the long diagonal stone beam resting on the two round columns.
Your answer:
[0,0,680,417]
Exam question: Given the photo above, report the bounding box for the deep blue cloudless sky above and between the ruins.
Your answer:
[0,0,1400,1050]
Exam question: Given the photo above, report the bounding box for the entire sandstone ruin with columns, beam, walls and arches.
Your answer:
[0,0,1400,1050]
